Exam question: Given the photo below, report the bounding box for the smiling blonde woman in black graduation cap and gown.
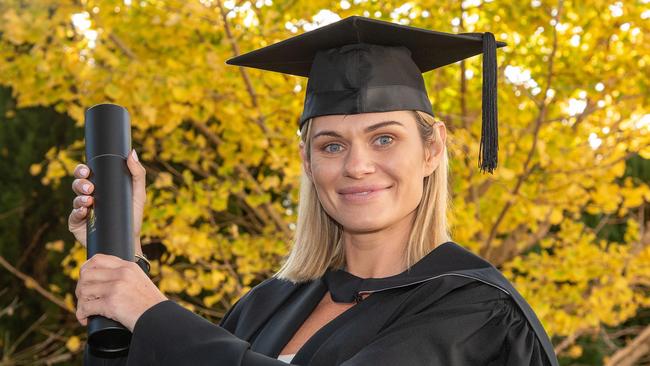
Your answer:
[69,17,558,366]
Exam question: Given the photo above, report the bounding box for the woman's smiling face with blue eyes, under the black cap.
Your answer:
[301,111,446,233]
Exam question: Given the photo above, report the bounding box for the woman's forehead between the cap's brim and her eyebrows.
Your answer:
[311,111,415,135]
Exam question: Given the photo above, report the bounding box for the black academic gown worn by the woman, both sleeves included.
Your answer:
[84,242,558,366]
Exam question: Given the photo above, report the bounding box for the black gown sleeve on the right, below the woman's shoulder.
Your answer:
[341,286,557,366]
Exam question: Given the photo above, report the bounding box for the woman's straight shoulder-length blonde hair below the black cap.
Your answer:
[273,111,450,283]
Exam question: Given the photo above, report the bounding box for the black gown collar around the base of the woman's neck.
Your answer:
[323,241,492,303]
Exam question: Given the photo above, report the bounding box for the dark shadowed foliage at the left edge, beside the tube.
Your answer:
[0,88,85,365]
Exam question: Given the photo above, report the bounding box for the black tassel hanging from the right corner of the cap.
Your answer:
[479,32,499,173]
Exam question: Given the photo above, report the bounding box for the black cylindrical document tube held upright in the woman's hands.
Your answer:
[85,104,134,356]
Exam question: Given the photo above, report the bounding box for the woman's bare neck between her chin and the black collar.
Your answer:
[342,212,415,278]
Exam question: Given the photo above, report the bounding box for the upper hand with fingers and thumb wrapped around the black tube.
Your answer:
[68,150,147,254]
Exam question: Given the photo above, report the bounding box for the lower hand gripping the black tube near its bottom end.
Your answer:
[75,253,167,332]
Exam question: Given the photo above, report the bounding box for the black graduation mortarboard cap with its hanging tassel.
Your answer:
[226,16,506,173]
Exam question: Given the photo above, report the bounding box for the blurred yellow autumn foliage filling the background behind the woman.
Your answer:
[0,0,650,365]
